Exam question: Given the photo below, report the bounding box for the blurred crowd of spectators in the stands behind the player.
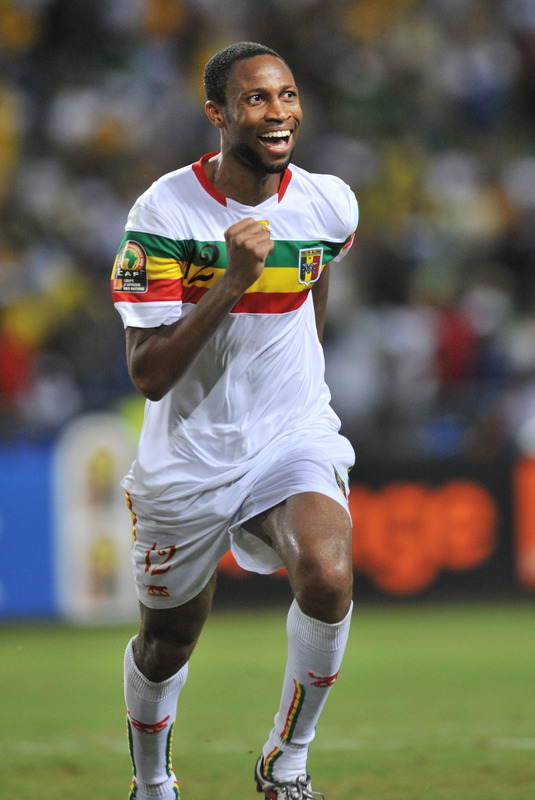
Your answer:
[0,0,535,459]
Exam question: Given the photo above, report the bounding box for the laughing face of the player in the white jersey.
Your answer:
[218,56,302,174]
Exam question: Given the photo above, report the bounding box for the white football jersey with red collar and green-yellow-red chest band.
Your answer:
[112,154,358,503]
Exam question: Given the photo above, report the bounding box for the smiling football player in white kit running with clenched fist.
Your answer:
[112,42,358,800]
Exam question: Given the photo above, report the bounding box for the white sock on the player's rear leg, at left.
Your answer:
[124,639,188,800]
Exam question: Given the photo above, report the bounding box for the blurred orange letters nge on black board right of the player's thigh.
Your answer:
[349,480,498,594]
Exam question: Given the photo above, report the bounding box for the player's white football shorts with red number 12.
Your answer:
[128,432,354,608]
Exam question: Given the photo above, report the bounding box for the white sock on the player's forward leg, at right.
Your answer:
[262,600,353,781]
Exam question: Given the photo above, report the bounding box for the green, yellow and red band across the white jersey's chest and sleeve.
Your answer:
[111,231,353,314]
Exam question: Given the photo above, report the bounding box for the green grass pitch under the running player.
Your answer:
[0,604,535,800]
